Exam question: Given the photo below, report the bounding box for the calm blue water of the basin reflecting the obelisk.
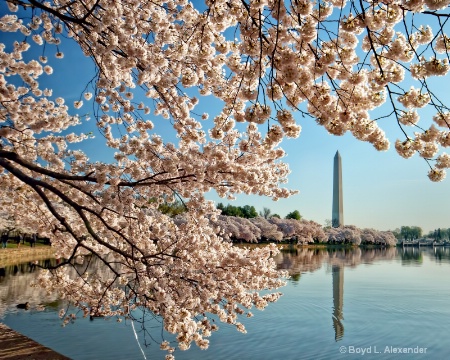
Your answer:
[0,248,450,360]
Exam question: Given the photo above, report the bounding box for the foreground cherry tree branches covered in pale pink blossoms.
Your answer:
[0,0,450,358]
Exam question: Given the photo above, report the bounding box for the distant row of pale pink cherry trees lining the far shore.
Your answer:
[142,201,398,246]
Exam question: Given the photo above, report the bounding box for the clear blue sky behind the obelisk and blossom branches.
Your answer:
[0,5,450,231]
